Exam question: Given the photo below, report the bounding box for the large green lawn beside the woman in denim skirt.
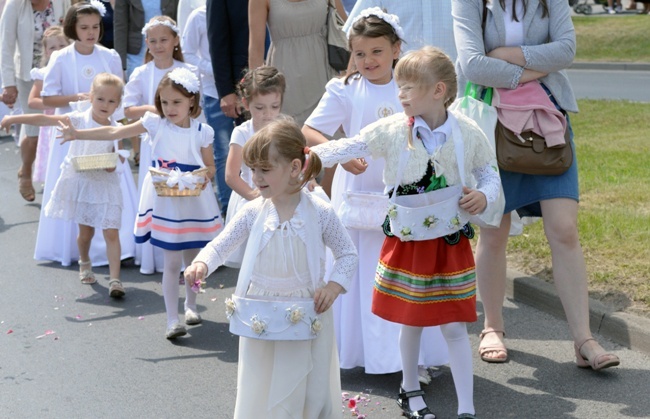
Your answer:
[508,100,650,314]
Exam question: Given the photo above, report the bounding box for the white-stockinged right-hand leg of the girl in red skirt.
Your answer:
[440,323,476,414]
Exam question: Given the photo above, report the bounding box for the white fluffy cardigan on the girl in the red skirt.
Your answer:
[311,112,501,203]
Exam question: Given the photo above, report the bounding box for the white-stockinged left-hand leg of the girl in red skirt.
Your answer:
[399,325,433,417]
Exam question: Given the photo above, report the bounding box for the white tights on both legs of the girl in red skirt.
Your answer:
[399,323,476,414]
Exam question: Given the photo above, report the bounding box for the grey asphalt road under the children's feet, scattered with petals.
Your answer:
[0,72,650,419]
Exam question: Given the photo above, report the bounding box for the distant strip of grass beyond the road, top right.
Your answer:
[573,15,650,63]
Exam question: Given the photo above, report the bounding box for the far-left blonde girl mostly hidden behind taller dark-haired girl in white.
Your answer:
[27,26,70,182]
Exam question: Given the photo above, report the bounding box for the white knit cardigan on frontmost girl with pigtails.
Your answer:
[194,190,358,292]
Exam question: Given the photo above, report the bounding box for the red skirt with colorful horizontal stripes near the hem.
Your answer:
[372,235,477,327]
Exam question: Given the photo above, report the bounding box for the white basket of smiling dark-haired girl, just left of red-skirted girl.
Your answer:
[337,191,388,231]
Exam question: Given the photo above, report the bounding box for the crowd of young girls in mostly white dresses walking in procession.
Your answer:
[1,2,616,419]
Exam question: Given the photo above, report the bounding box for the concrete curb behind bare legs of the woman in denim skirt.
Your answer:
[506,269,650,355]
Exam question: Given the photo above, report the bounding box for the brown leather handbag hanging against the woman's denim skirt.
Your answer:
[495,122,573,175]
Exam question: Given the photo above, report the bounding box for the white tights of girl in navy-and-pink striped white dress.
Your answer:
[163,249,200,327]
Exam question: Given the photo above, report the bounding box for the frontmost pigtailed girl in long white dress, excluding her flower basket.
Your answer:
[185,118,357,419]
